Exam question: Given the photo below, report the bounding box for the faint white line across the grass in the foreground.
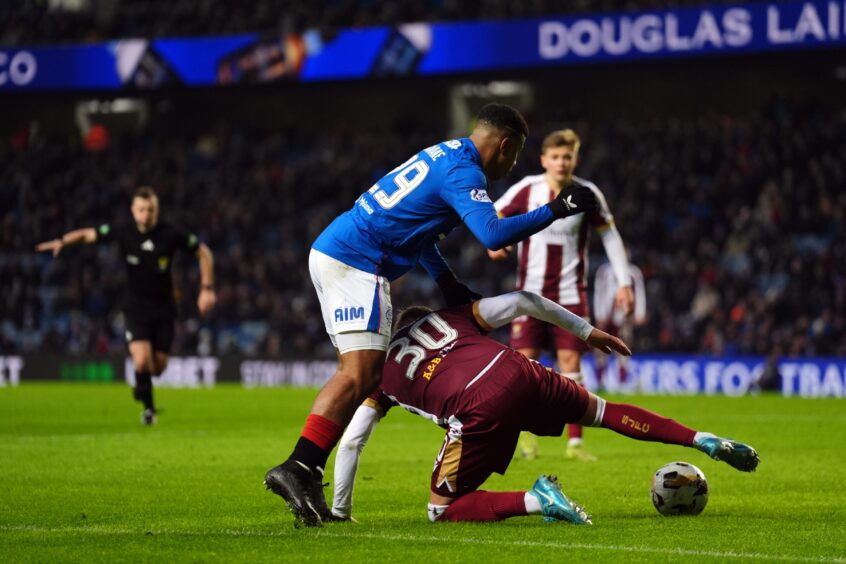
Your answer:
[0,525,846,563]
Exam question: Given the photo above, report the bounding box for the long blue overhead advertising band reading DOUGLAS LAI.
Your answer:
[0,0,846,92]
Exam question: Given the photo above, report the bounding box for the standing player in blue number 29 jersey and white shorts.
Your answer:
[265,104,598,526]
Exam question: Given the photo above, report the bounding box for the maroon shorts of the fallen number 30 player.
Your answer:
[431,351,589,497]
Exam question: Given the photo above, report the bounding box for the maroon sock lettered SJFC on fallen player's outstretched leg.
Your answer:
[602,401,696,446]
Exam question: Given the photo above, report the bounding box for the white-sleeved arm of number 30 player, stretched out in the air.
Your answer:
[473,290,632,356]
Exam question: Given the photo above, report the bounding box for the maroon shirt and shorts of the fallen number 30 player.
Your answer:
[372,305,588,497]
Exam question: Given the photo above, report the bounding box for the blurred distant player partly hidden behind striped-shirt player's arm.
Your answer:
[593,262,646,390]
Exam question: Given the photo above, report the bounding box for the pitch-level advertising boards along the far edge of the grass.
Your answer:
[6,354,846,398]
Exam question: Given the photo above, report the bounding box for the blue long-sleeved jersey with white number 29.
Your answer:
[312,138,555,280]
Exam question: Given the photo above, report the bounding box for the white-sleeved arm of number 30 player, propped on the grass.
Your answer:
[332,404,379,519]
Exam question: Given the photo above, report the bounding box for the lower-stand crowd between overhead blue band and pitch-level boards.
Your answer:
[0,103,846,358]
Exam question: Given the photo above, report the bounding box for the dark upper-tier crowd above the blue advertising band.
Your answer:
[6,0,772,45]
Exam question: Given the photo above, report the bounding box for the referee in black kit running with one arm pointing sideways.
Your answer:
[36,187,217,425]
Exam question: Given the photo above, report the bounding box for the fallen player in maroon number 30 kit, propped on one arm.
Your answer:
[332,291,758,524]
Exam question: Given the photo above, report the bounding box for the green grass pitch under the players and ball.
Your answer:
[0,383,846,562]
